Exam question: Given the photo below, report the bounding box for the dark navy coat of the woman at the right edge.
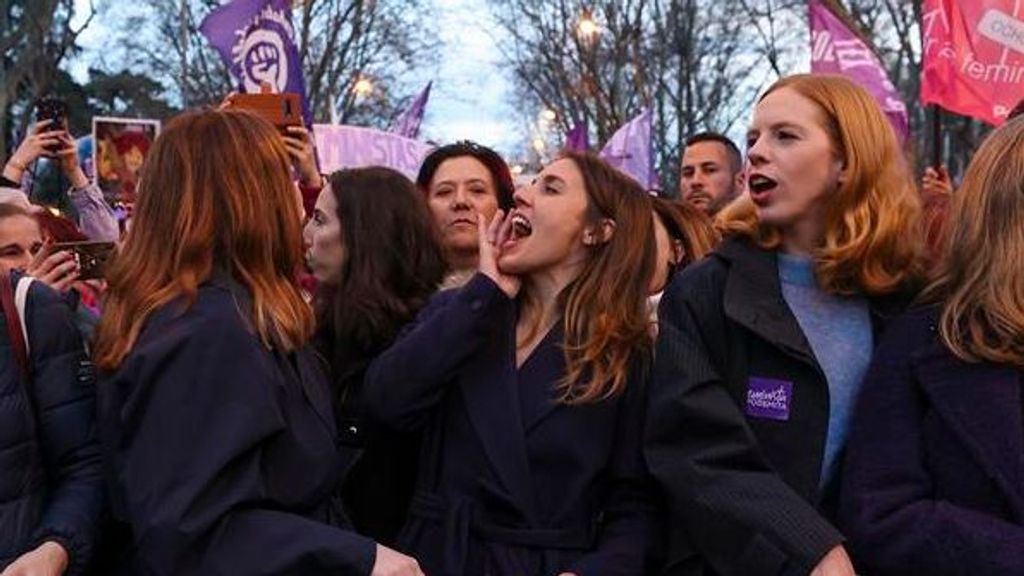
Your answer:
[841,307,1024,576]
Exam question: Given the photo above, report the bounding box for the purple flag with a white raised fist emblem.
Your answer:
[199,0,312,126]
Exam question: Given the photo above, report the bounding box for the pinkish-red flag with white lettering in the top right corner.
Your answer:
[921,0,1024,125]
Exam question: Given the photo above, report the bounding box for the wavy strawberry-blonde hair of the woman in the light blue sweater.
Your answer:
[716,74,923,295]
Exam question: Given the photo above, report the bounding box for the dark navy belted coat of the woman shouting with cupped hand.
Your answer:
[366,275,660,576]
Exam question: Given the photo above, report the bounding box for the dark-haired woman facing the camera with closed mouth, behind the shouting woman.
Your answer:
[416,140,515,288]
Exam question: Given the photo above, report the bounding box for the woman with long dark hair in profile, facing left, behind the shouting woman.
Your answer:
[303,167,444,544]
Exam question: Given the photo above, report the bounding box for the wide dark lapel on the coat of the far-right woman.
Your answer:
[912,343,1024,520]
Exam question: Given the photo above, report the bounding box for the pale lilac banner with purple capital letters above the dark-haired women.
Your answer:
[313,124,433,180]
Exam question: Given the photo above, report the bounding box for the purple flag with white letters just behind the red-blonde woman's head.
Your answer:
[808,0,909,141]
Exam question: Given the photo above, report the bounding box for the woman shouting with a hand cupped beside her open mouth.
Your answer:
[367,153,660,576]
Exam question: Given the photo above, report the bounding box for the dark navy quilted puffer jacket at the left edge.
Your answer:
[0,275,103,575]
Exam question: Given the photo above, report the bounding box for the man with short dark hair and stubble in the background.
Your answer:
[679,132,743,216]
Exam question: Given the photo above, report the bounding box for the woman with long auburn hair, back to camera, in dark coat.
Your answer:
[94,111,421,575]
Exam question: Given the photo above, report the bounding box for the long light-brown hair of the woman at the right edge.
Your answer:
[928,118,1024,367]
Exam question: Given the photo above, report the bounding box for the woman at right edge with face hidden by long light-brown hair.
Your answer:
[842,114,1024,576]
